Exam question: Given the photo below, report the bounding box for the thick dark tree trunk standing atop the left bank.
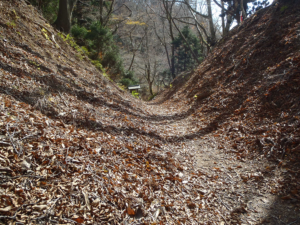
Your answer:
[53,0,77,33]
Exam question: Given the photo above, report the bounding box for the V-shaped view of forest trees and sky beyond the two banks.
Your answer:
[28,0,269,100]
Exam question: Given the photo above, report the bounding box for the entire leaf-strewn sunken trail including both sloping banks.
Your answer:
[0,0,300,225]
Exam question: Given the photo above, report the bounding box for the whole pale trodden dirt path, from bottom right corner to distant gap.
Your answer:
[142,102,300,225]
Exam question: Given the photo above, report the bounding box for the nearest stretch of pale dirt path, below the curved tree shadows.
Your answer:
[193,140,300,224]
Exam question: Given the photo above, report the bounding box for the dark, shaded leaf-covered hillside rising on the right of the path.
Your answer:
[156,0,300,181]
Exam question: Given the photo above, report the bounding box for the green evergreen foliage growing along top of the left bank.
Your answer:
[28,0,137,85]
